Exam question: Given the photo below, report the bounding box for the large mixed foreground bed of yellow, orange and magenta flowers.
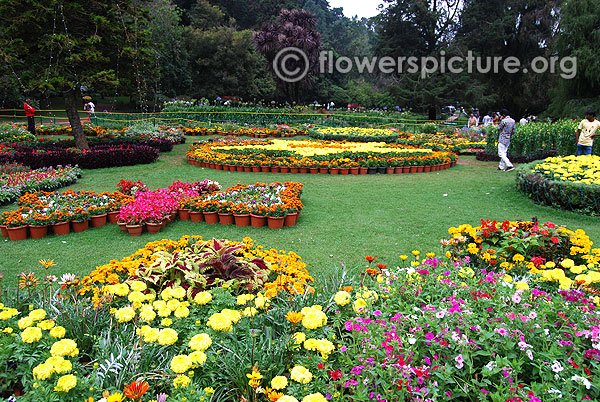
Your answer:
[0,222,600,402]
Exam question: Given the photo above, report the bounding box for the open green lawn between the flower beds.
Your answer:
[0,138,600,285]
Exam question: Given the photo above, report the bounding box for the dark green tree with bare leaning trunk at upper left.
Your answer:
[0,0,153,149]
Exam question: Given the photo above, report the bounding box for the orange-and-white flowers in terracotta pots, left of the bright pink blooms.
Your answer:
[0,190,133,240]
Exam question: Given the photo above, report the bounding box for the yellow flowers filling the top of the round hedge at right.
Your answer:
[533,155,600,185]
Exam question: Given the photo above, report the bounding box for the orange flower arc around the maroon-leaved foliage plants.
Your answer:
[78,236,314,305]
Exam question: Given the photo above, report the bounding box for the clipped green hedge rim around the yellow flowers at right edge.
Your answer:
[515,156,600,216]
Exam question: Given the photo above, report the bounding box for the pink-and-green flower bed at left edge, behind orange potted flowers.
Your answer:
[0,165,81,205]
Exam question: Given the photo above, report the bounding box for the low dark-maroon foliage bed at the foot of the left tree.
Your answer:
[0,145,159,169]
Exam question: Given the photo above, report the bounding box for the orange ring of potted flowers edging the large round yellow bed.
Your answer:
[187,140,458,175]
